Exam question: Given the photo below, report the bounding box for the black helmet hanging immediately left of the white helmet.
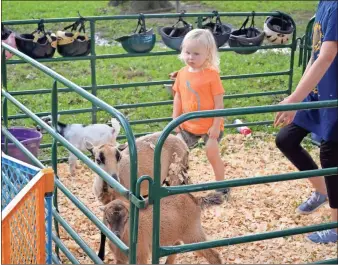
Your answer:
[229,12,264,54]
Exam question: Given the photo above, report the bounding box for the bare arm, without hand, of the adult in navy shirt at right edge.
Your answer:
[288,41,338,103]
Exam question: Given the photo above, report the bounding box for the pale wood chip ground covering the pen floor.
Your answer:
[54,133,337,264]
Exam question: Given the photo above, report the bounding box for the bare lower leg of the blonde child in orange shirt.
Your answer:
[205,138,224,181]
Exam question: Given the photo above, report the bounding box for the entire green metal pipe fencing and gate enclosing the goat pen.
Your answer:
[1,12,332,264]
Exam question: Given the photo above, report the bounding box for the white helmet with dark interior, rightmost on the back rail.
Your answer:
[264,15,294,44]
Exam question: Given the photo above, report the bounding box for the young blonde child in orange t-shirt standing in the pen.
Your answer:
[171,29,228,193]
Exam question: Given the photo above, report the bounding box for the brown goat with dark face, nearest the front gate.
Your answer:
[99,193,224,264]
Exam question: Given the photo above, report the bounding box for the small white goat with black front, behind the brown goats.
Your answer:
[37,115,121,175]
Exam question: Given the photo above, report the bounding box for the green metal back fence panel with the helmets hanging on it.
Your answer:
[3,12,297,134]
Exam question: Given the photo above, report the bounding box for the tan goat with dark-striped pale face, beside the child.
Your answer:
[86,132,189,204]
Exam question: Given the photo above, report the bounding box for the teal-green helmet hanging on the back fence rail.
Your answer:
[116,14,156,53]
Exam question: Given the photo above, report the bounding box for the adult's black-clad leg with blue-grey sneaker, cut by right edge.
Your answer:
[308,141,338,243]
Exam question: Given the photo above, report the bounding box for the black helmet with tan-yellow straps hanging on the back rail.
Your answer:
[56,16,90,57]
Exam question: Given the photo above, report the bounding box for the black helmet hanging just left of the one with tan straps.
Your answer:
[15,20,56,59]
